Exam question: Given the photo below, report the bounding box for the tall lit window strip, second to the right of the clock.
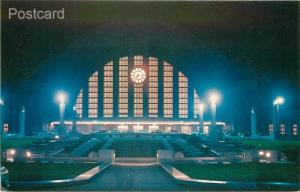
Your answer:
[164,62,173,118]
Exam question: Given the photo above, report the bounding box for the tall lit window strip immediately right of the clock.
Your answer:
[148,57,158,117]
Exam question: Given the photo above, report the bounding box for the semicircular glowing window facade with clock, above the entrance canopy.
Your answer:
[75,55,199,120]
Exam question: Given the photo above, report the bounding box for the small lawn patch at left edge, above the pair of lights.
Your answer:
[1,138,40,150]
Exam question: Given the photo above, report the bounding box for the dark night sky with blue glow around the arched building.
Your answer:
[1,1,300,134]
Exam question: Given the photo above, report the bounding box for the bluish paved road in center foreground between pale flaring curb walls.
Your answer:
[56,165,193,191]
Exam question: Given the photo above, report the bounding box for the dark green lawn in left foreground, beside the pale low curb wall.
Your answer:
[1,162,97,181]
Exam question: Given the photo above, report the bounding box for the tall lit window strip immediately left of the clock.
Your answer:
[119,57,128,117]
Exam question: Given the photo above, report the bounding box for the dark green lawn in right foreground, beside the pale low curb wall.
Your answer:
[174,163,300,183]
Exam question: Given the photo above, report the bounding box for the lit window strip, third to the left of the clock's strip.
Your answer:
[88,71,98,118]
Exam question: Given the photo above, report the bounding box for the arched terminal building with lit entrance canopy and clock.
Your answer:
[51,55,227,134]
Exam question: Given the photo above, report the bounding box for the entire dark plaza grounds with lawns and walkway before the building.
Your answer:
[2,133,299,191]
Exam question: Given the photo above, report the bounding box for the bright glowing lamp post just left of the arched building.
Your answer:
[56,92,67,137]
